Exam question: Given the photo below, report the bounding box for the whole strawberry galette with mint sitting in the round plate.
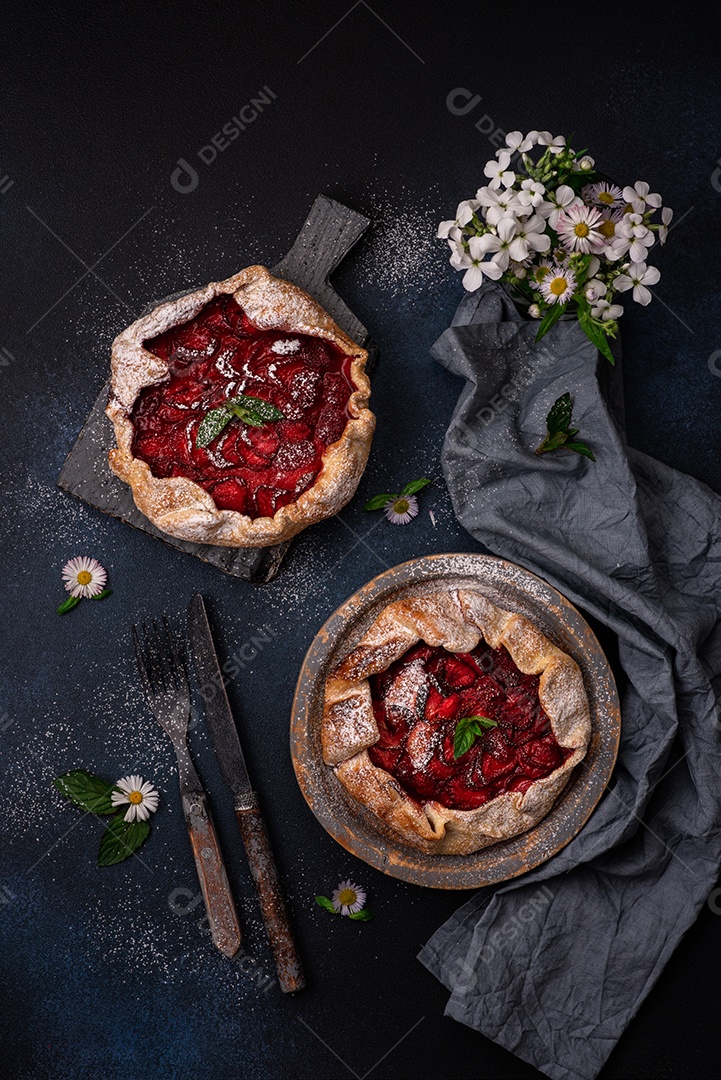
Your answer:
[322,589,590,854]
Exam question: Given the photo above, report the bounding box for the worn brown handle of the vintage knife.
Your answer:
[235,807,305,994]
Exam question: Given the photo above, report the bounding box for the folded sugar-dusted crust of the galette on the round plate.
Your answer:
[322,590,590,854]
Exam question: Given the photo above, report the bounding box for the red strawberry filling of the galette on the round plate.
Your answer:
[368,643,573,810]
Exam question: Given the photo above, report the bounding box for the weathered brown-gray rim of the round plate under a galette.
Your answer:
[290,552,621,890]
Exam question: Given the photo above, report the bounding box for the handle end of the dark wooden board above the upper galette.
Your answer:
[271,195,370,347]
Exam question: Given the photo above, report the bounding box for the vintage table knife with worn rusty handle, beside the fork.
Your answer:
[188,593,305,994]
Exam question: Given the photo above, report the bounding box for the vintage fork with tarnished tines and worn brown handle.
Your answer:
[133,616,242,956]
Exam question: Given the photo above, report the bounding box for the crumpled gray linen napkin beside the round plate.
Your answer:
[419,283,721,1080]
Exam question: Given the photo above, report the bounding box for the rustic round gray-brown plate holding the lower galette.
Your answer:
[290,554,621,889]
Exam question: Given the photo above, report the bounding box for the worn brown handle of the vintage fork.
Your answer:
[182,794,242,956]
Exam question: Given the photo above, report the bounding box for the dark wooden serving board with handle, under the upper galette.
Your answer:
[57,195,378,583]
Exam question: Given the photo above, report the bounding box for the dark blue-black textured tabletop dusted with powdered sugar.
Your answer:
[0,0,721,1080]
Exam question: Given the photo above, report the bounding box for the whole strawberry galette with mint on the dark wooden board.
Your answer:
[107,266,376,548]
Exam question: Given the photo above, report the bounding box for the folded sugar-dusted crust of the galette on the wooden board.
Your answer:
[106,266,376,548]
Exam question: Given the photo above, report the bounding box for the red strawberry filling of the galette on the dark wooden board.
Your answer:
[132,296,355,517]
